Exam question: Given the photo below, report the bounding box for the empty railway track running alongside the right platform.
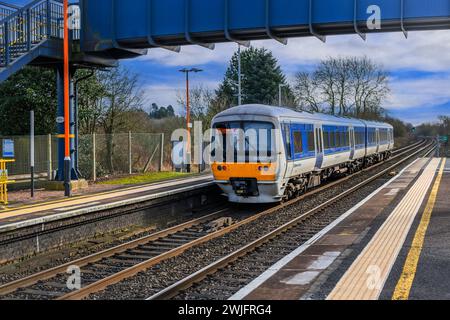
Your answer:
[147,142,434,300]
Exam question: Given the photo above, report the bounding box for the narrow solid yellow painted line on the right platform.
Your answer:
[392,158,446,300]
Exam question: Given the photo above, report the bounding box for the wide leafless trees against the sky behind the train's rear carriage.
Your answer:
[295,57,390,118]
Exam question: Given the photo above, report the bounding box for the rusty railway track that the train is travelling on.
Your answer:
[0,142,425,299]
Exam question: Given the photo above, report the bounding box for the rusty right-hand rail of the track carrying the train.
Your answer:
[57,141,426,300]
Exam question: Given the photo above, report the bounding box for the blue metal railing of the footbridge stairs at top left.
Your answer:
[0,0,80,68]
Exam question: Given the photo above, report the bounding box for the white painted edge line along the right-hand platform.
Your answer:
[229,159,420,300]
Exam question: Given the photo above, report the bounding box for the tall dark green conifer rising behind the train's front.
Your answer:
[216,47,294,105]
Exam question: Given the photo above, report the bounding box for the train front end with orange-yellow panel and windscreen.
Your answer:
[211,107,285,203]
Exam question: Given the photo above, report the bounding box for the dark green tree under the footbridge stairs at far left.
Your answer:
[0,67,57,135]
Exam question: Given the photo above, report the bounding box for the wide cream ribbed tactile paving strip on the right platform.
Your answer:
[327,159,440,300]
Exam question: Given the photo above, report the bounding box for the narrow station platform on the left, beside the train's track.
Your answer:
[0,175,214,233]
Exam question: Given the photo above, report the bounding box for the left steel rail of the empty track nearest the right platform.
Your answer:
[147,144,434,300]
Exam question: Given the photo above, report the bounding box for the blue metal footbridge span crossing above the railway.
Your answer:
[81,0,450,51]
